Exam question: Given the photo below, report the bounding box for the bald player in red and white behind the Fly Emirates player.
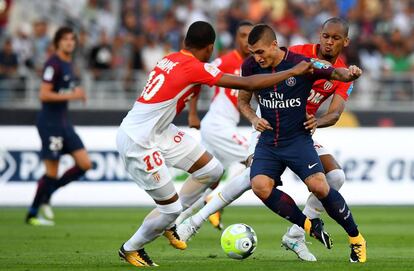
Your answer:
[177,18,366,261]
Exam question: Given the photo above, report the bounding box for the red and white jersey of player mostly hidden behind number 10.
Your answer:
[203,50,243,126]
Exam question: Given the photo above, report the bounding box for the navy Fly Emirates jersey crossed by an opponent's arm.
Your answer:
[242,48,334,146]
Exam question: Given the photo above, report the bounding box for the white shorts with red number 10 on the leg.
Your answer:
[116,124,206,190]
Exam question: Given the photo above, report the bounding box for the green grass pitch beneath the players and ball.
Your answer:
[0,206,414,271]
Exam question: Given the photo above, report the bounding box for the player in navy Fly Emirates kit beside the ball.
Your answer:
[239,24,366,262]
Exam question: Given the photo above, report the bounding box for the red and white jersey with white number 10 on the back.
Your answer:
[120,50,223,148]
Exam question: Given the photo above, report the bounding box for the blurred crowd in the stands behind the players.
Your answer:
[0,0,414,105]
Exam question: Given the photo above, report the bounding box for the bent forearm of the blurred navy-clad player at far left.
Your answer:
[39,82,86,103]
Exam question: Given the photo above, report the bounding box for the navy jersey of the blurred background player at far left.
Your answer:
[38,55,75,126]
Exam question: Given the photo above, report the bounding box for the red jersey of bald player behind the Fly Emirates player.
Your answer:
[289,44,353,115]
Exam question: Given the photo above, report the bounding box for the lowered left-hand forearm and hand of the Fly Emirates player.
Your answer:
[237,90,273,132]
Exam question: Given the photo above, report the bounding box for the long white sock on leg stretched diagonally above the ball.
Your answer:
[191,168,251,228]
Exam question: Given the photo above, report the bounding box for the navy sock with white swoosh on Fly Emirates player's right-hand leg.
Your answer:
[320,188,359,237]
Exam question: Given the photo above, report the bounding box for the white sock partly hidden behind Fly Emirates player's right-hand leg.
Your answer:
[303,169,345,219]
